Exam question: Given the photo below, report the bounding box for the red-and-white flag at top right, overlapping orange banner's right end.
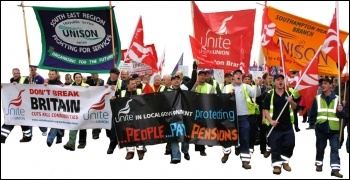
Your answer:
[322,4,346,70]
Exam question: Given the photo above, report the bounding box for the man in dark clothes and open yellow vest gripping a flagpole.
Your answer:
[263,74,297,174]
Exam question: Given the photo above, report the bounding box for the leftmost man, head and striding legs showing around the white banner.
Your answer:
[1,68,32,143]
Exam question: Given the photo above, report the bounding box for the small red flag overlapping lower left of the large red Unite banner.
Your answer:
[190,35,217,68]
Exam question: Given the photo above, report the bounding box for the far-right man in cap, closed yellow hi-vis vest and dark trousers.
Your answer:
[309,77,346,178]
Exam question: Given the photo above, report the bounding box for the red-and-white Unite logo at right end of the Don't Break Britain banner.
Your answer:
[83,92,110,122]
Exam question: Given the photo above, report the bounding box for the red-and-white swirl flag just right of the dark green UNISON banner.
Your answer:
[124,16,158,71]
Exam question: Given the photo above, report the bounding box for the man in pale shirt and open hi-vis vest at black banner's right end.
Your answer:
[221,69,261,169]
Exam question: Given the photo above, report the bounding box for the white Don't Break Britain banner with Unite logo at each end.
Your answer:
[1,83,114,130]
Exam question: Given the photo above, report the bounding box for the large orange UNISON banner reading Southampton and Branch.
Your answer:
[264,7,349,76]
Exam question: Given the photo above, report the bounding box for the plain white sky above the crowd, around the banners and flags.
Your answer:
[1,1,349,83]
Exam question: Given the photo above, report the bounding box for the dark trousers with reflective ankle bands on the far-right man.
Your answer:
[315,126,340,172]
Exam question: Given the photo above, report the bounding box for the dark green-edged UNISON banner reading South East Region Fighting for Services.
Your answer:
[33,6,121,73]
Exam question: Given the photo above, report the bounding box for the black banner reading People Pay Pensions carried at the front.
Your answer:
[111,90,238,148]
